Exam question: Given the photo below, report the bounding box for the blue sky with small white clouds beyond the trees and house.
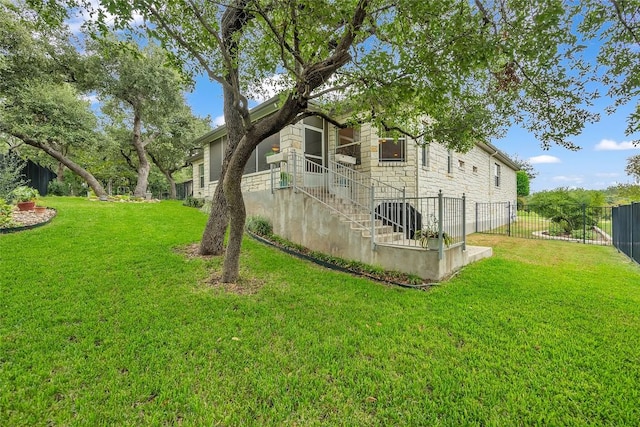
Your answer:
[187,77,640,192]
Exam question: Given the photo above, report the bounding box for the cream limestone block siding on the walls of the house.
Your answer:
[193,114,516,214]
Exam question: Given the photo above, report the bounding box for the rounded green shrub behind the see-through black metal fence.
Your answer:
[526,188,605,233]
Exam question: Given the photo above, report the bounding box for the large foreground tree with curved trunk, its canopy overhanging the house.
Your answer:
[33,0,596,281]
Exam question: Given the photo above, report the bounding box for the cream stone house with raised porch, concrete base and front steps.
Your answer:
[192,99,518,280]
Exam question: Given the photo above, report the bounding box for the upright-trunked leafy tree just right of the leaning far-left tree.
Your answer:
[86,38,202,197]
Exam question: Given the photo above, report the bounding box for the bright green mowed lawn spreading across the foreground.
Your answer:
[0,198,640,426]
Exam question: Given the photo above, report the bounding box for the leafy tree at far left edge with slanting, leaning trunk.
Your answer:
[0,1,105,194]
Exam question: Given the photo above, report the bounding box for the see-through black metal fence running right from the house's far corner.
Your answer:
[476,202,613,245]
